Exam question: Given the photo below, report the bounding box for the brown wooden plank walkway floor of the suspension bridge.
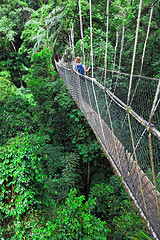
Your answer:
[81,101,160,239]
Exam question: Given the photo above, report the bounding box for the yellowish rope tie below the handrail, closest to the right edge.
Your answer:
[149,131,160,218]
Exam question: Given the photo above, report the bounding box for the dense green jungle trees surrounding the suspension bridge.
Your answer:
[0,0,160,240]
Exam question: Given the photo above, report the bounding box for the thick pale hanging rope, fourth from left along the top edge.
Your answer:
[127,0,142,106]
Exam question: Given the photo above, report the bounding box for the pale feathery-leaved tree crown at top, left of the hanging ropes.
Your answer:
[20,5,64,54]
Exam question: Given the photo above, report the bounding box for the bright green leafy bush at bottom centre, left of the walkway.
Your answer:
[49,189,109,239]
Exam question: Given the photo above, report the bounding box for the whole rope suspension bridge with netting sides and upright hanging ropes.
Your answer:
[56,0,160,239]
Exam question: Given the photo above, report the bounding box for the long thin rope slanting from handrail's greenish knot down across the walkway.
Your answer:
[127,113,148,217]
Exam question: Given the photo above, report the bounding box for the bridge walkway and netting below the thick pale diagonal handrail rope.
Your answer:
[56,59,160,239]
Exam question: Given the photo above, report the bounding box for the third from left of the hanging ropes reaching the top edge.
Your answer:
[104,0,109,87]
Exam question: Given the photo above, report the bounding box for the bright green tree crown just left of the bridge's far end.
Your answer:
[25,49,56,110]
